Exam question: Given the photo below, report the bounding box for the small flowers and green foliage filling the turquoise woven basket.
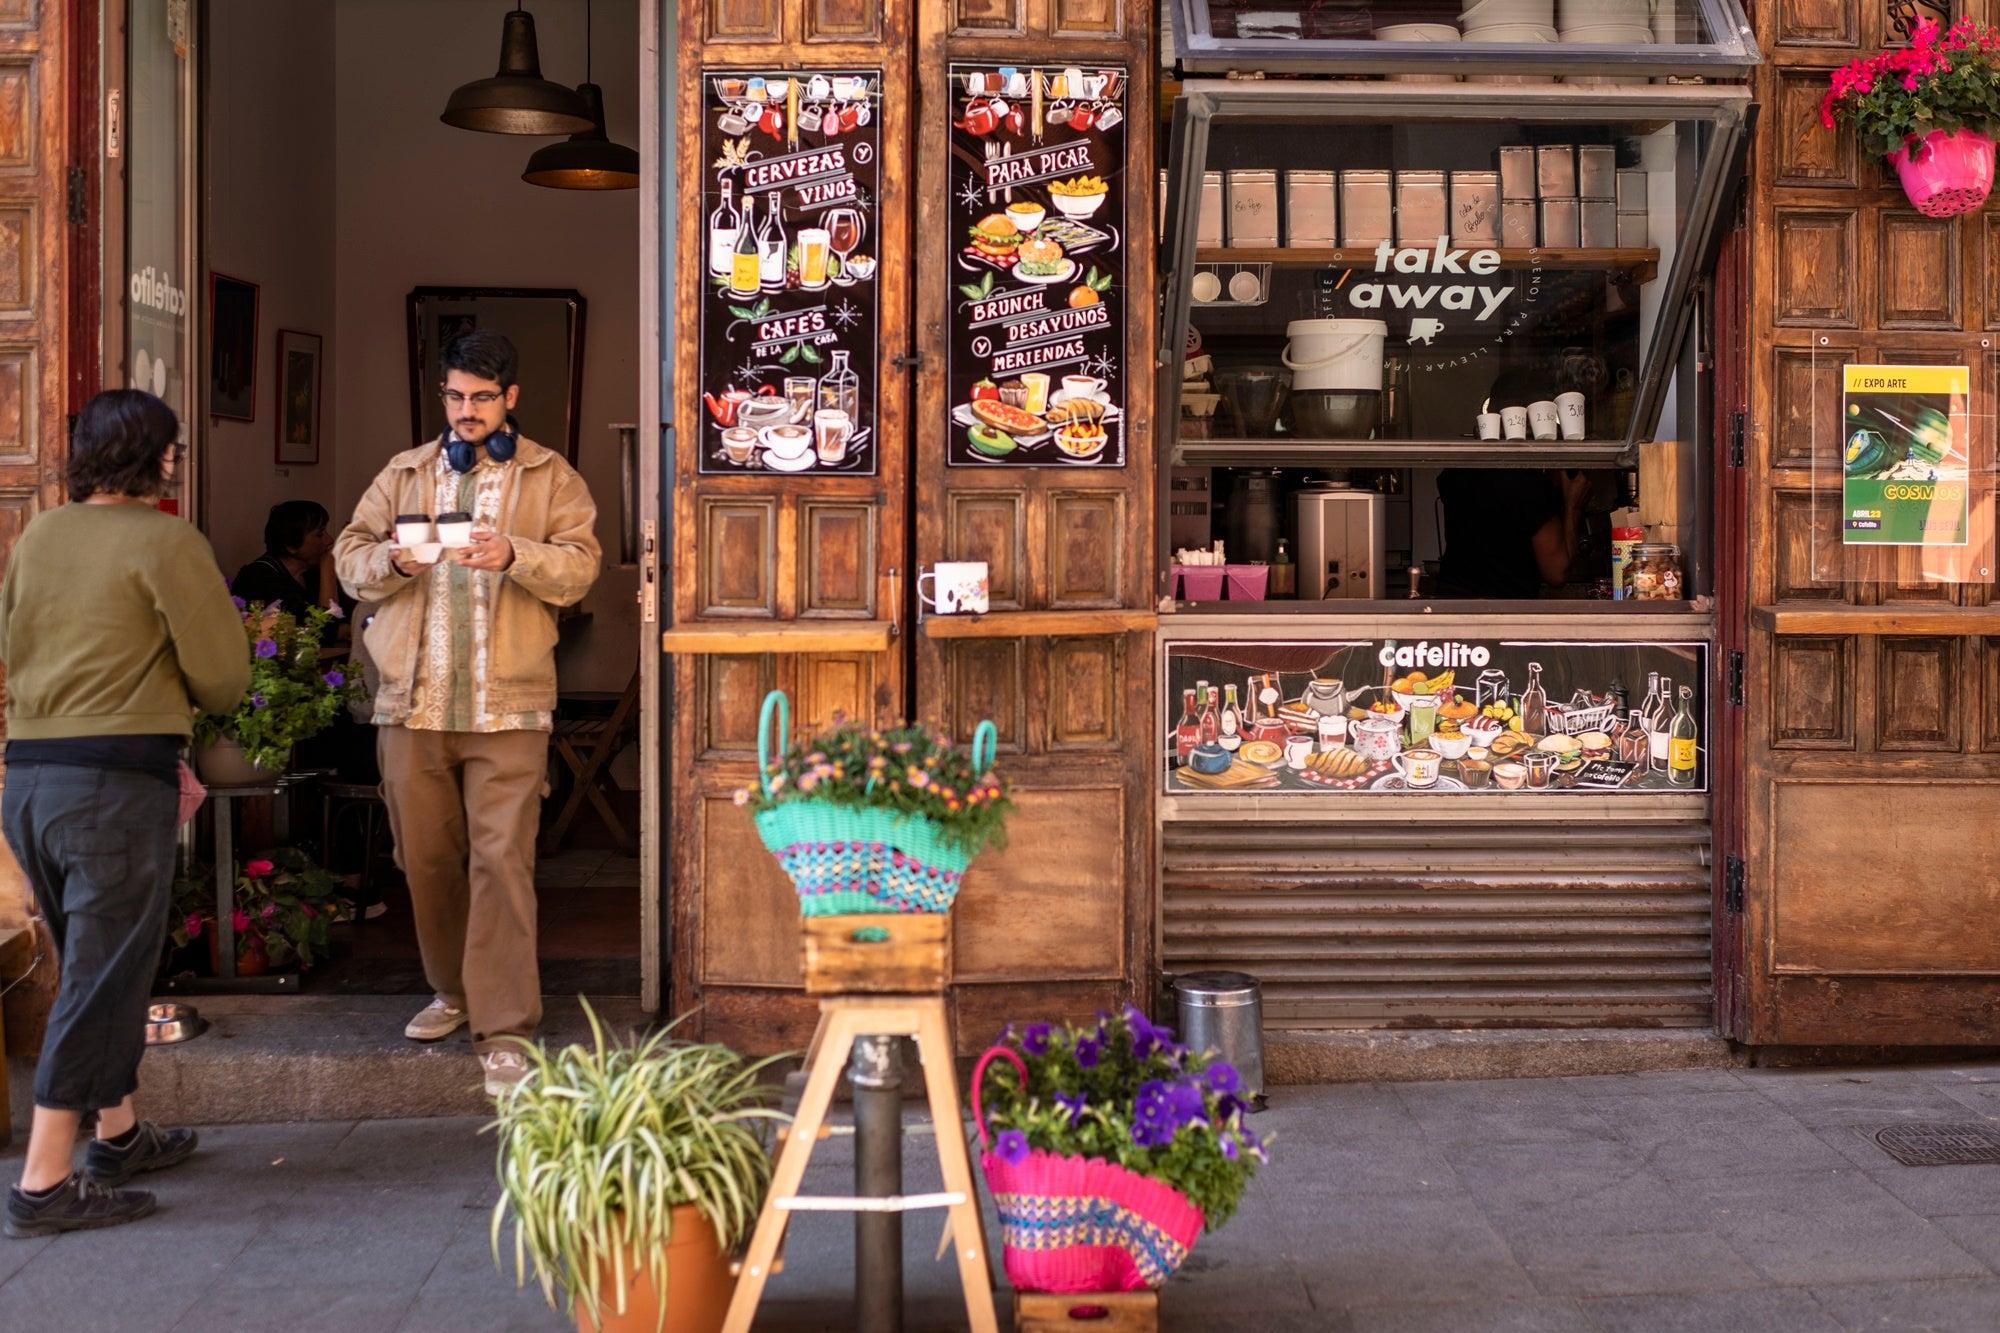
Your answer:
[736,715,1014,857]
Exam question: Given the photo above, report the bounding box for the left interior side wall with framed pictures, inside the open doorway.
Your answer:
[200,0,340,572]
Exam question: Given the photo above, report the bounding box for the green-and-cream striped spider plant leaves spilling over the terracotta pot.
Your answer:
[490,1003,786,1325]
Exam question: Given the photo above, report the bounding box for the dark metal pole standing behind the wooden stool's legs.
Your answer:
[848,1037,902,1333]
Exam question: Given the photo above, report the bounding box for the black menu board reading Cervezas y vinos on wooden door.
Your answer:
[700,70,882,476]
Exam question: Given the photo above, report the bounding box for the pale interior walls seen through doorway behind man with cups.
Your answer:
[210,0,638,691]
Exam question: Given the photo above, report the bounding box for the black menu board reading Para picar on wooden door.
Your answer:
[946,64,1126,468]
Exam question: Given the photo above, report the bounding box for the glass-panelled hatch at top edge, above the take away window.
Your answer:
[1174,0,1758,80]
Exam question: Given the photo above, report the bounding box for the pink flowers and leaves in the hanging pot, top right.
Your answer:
[1820,18,2000,162]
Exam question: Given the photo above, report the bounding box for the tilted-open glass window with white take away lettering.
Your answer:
[1162,82,1746,462]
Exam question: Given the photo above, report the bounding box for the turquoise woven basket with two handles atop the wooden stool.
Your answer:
[744,691,1006,917]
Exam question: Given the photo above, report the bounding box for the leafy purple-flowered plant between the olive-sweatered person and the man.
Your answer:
[194,598,366,771]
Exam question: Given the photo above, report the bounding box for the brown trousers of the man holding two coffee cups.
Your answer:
[378,727,548,1053]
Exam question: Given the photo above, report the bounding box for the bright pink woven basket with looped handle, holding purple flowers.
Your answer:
[972,1047,1202,1291]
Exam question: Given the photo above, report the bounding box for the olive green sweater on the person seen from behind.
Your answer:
[0,504,250,741]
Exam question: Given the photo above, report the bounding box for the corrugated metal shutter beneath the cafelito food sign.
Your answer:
[1160,823,1712,1029]
